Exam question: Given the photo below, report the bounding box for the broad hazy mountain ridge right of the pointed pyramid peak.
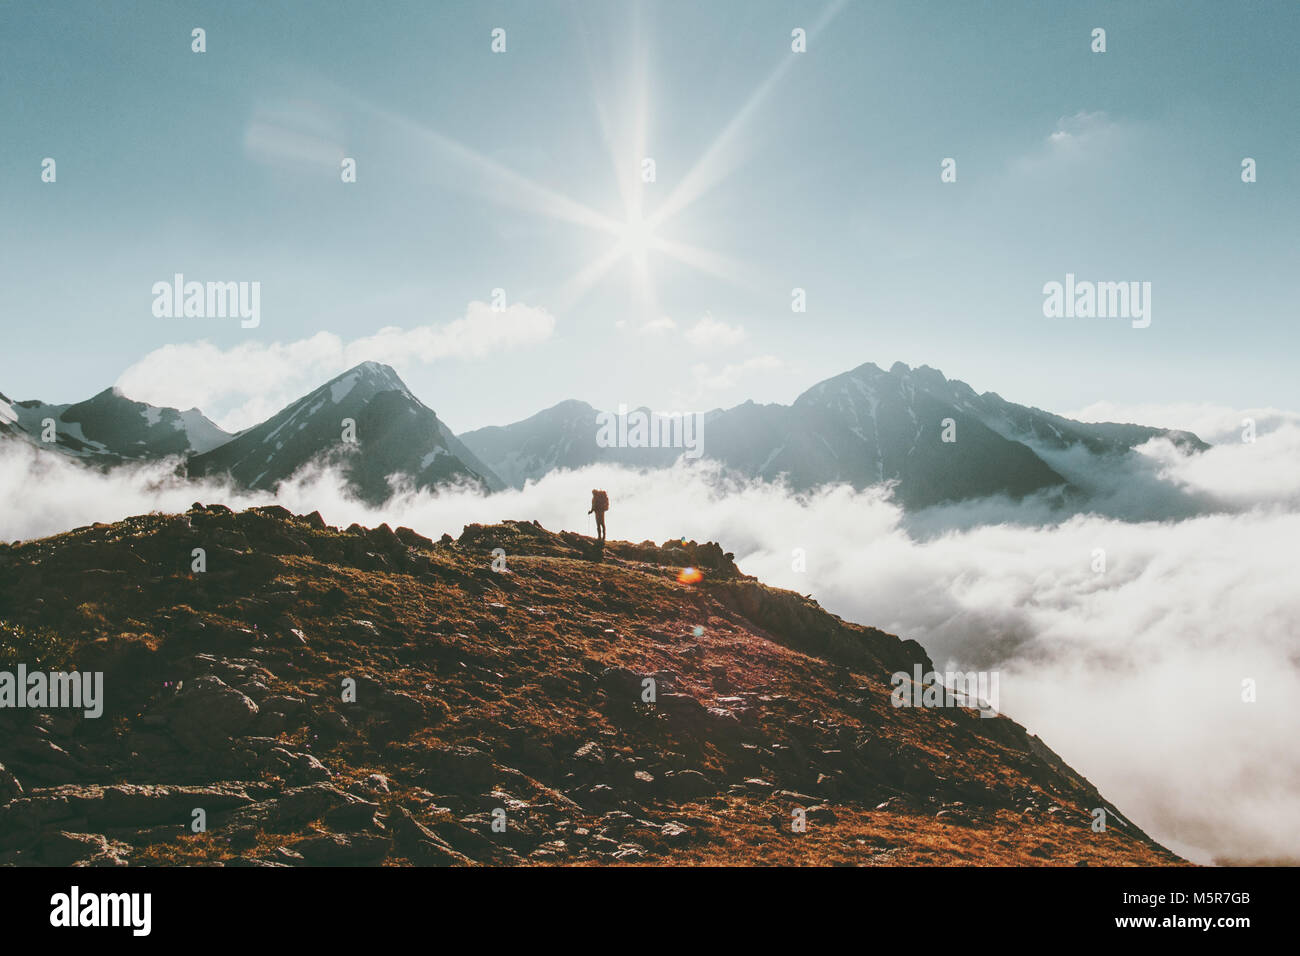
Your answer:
[462,363,1208,507]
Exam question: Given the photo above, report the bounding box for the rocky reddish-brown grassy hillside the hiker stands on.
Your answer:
[0,505,1182,866]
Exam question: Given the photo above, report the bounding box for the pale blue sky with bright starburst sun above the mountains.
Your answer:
[0,0,1300,432]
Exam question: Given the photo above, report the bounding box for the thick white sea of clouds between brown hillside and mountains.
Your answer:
[0,414,1300,862]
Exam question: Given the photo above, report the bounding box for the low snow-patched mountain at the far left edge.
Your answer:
[0,389,230,466]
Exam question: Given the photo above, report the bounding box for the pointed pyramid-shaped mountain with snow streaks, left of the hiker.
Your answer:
[189,362,504,502]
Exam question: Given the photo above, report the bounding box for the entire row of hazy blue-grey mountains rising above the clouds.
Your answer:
[0,362,1209,509]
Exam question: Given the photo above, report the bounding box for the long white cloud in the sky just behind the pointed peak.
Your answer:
[117,302,555,431]
